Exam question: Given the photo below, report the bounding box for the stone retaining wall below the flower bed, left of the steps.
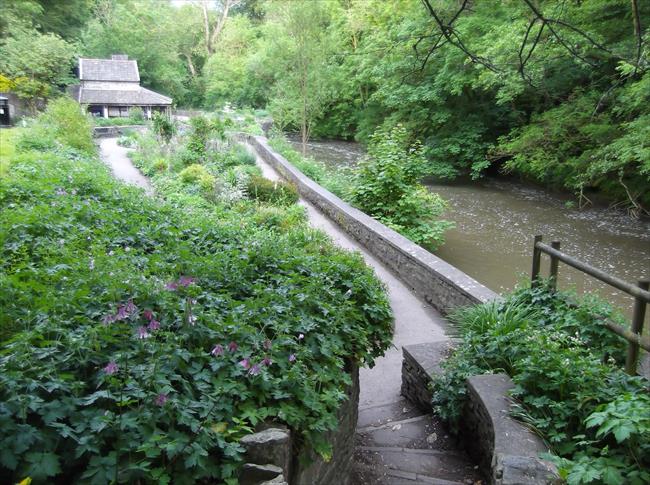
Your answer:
[239,365,359,485]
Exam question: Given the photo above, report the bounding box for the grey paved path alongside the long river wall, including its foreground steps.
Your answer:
[248,146,480,485]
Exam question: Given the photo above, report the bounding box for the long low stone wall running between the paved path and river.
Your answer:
[244,135,498,313]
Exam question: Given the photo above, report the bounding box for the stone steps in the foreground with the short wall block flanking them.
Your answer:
[351,342,485,485]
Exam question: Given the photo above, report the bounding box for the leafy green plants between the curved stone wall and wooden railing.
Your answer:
[434,287,650,485]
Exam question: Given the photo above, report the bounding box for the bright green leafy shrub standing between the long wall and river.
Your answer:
[351,125,452,248]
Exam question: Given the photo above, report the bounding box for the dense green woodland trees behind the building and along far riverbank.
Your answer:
[0,0,650,212]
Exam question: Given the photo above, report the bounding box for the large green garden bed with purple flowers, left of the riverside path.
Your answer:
[0,99,392,483]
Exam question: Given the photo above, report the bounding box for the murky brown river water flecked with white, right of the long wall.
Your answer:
[294,141,650,320]
